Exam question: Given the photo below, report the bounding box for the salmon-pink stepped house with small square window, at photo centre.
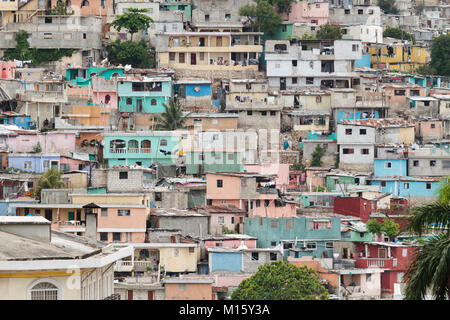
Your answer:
[206,172,296,218]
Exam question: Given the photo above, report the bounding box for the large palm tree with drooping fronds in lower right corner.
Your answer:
[404,177,450,300]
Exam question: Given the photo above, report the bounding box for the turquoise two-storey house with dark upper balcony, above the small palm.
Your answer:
[117,77,172,113]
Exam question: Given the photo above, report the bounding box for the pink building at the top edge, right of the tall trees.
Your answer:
[283,1,328,26]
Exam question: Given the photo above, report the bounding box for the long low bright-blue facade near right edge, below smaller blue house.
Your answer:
[372,177,441,197]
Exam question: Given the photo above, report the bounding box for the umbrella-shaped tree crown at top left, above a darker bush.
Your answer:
[111,8,154,41]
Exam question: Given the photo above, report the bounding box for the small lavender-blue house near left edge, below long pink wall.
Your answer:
[8,153,60,173]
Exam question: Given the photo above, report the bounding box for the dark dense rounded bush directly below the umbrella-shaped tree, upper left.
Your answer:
[106,39,155,68]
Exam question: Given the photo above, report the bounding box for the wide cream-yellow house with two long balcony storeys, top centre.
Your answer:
[158,32,263,71]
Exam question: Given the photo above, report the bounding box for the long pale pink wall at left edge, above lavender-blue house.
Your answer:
[0,132,75,153]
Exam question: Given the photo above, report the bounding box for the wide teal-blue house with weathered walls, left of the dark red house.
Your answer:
[244,217,341,258]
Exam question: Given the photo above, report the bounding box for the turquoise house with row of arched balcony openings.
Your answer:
[103,131,181,168]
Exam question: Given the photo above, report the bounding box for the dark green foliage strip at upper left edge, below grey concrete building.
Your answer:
[3,30,75,65]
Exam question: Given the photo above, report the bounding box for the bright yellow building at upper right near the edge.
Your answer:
[369,43,430,71]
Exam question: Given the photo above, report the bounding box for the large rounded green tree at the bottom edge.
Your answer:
[231,261,328,300]
